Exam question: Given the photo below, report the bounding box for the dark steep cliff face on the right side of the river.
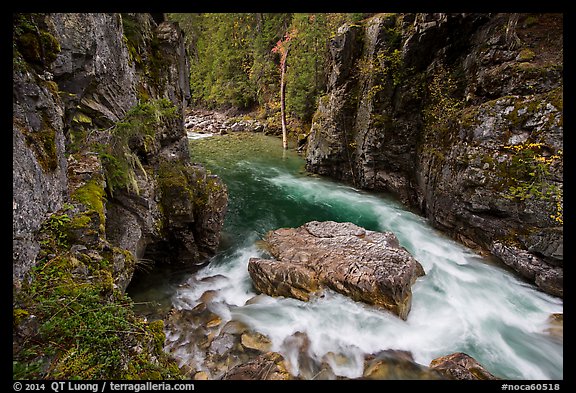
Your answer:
[307,14,563,296]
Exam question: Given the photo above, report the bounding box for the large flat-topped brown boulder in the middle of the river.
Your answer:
[248,221,424,320]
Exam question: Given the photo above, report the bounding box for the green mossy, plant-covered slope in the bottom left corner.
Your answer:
[13,240,182,380]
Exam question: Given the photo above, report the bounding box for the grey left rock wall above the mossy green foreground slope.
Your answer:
[13,13,227,288]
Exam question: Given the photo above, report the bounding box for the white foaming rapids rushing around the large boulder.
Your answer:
[166,146,563,379]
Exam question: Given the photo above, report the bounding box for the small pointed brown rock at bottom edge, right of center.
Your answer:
[430,352,499,380]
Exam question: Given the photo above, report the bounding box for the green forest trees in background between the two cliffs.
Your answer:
[167,13,370,123]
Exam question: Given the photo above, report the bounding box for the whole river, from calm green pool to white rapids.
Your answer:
[128,134,563,380]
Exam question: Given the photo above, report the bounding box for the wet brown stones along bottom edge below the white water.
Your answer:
[166,284,498,380]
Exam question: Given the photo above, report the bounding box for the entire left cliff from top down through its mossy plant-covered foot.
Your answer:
[13,13,227,379]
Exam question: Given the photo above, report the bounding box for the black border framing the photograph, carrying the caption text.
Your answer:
[9,0,576,392]
